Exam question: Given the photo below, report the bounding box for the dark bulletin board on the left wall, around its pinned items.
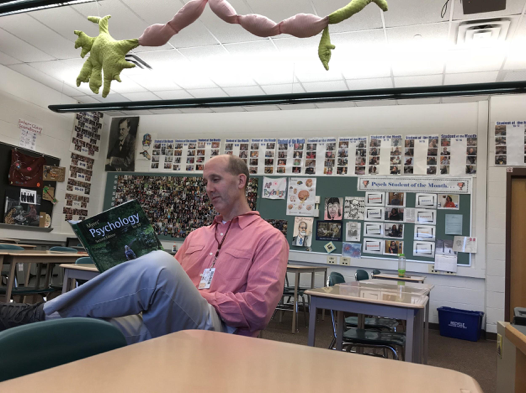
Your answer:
[0,142,60,225]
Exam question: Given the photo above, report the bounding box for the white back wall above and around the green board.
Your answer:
[103,101,488,322]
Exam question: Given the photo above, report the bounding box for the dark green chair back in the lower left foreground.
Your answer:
[0,318,126,382]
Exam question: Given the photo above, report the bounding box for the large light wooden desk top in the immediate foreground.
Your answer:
[0,330,482,393]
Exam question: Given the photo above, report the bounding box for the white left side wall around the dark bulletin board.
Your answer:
[0,66,106,241]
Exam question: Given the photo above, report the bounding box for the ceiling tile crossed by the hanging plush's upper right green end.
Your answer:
[312,0,383,35]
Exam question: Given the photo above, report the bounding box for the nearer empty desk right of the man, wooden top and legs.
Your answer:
[305,281,428,363]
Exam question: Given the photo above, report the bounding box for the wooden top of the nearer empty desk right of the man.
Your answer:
[305,281,428,308]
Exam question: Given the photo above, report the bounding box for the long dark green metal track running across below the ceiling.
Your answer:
[48,81,526,113]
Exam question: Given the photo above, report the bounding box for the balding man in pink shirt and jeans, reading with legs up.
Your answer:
[0,155,289,344]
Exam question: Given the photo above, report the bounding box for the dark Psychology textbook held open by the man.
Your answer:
[69,200,163,273]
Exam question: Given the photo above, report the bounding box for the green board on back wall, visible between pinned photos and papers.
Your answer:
[104,172,471,265]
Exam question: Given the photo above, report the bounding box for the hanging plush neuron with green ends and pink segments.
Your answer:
[75,0,387,97]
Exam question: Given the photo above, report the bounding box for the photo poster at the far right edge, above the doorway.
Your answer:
[495,121,526,166]
